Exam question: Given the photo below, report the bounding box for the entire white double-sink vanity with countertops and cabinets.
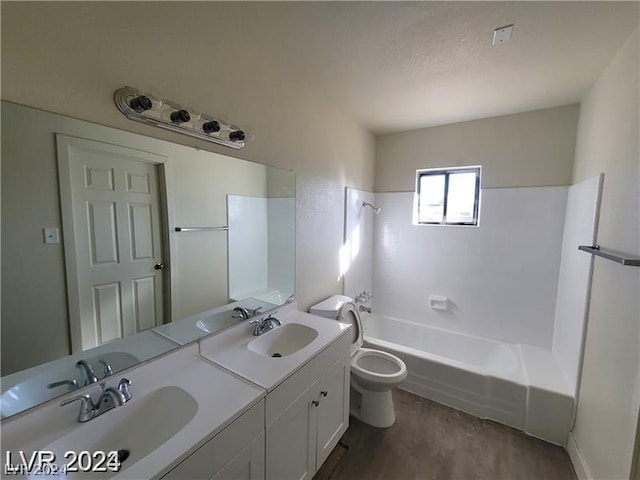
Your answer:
[2,303,350,479]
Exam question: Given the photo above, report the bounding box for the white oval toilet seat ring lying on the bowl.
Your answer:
[351,348,407,385]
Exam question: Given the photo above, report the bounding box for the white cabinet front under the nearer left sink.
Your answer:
[162,401,265,480]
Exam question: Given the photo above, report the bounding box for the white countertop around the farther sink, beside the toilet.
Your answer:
[199,302,351,391]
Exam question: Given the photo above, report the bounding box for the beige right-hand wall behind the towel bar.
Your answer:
[573,29,640,479]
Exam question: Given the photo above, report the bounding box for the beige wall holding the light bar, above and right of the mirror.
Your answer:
[1,2,374,316]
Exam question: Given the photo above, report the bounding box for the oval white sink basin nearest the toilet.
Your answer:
[247,323,318,358]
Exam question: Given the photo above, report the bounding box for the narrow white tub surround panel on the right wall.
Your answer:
[552,175,602,397]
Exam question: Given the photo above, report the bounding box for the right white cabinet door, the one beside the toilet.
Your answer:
[316,355,351,468]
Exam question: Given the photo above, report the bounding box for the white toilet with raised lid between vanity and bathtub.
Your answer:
[309,295,407,428]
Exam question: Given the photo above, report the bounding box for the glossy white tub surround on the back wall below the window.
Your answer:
[373,187,567,349]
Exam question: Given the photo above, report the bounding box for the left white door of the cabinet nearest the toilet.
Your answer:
[266,382,317,480]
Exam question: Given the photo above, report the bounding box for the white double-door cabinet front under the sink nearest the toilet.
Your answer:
[266,335,350,480]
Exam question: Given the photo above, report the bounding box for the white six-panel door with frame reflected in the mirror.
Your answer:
[57,135,166,353]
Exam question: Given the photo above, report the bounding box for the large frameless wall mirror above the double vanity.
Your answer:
[1,102,295,418]
